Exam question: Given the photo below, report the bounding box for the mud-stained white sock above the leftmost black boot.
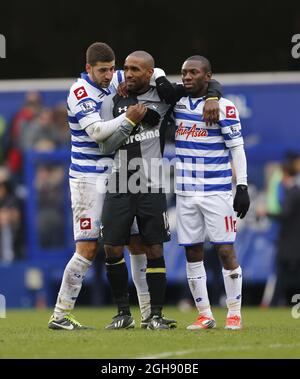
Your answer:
[54,253,92,319]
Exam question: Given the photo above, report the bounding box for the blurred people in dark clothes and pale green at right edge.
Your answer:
[256,152,300,305]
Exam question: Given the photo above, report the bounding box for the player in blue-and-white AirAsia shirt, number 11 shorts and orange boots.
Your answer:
[158,55,250,330]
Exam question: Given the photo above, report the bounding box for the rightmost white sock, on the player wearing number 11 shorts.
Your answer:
[222,266,242,317]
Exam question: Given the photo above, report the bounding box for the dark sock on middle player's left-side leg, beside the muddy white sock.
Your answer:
[105,256,131,315]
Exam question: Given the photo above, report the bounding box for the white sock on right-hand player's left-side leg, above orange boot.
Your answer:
[186,261,213,317]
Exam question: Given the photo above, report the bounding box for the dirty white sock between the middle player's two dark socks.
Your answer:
[130,254,151,320]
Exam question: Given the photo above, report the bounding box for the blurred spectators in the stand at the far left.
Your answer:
[0,91,70,263]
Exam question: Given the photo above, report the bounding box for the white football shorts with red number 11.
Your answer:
[176,192,236,246]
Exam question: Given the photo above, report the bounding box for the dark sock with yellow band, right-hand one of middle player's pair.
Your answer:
[146,256,167,317]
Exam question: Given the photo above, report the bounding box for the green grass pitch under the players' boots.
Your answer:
[0,307,300,359]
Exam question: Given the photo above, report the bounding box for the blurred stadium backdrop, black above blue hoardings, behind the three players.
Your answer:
[0,0,300,314]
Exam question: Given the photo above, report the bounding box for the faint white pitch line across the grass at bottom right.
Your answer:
[134,343,300,359]
